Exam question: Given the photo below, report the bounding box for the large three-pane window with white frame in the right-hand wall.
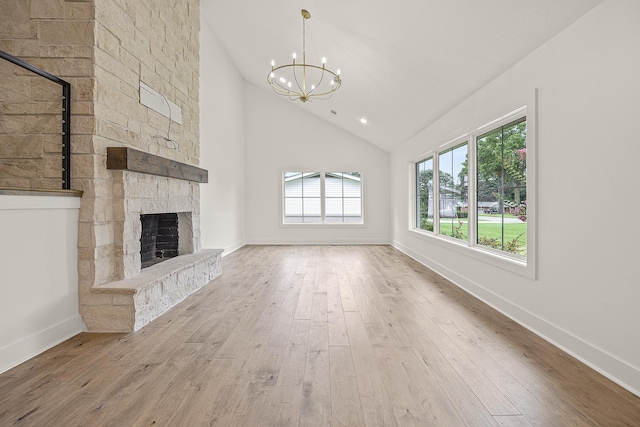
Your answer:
[411,105,536,278]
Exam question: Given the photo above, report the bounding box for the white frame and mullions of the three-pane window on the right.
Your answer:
[409,100,537,280]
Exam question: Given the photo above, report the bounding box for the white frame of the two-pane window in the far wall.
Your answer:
[279,168,366,228]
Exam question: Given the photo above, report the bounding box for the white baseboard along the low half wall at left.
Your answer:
[0,315,86,373]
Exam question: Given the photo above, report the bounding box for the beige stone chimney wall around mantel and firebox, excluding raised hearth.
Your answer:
[0,0,200,330]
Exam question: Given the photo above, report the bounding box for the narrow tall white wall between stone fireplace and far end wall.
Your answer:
[200,18,245,255]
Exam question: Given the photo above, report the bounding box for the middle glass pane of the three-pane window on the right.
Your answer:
[438,142,469,240]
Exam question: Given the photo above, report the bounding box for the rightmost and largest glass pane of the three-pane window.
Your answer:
[476,117,527,256]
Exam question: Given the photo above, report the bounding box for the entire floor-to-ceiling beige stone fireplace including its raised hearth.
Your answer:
[0,0,215,332]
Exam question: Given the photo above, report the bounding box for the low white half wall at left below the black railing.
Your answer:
[0,195,84,372]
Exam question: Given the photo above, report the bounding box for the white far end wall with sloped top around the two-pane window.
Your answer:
[245,82,390,244]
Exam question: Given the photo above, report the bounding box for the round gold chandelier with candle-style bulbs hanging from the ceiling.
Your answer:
[267,9,342,102]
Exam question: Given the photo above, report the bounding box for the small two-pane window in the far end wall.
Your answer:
[283,172,363,224]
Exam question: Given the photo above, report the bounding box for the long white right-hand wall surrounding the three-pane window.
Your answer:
[391,0,640,394]
